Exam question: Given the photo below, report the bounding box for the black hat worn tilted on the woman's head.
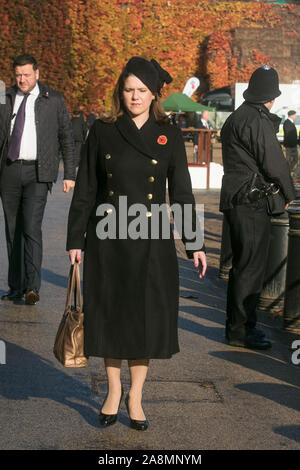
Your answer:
[125,57,173,94]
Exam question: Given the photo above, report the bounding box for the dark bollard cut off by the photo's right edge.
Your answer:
[283,204,300,333]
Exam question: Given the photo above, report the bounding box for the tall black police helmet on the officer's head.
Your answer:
[243,65,281,103]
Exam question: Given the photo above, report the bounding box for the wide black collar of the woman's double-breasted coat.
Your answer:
[116,113,158,159]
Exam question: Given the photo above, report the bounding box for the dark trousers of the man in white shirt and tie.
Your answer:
[0,163,48,290]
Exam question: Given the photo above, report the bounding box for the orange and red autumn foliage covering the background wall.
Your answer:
[0,0,300,113]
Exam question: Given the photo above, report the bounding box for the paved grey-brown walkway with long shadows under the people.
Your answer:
[0,171,300,450]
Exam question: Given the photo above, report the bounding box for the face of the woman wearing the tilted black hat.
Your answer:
[122,75,155,118]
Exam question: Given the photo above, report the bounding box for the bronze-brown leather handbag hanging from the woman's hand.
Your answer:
[53,263,88,367]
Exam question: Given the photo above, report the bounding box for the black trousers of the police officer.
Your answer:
[224,199,271,341]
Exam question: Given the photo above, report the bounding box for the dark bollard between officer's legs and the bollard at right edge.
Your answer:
[258,211,289,313]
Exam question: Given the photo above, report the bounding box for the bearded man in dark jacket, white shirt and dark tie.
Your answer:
[0,54,75,305]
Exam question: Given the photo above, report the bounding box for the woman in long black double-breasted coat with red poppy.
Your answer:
[67,57,206,430]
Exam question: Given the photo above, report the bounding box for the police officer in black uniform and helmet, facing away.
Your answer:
[220,65,295,349]
